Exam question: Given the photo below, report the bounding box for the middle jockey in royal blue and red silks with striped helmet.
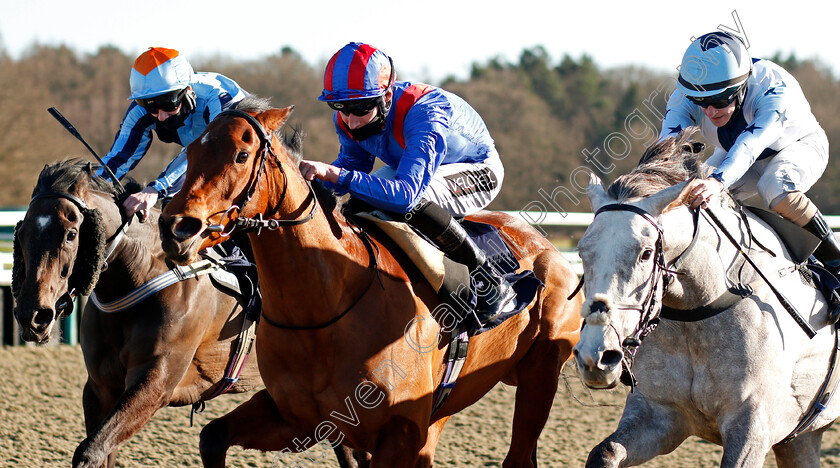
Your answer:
[300,42,514,323]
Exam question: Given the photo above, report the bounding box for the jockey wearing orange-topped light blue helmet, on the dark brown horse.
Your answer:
[99,47,248,217]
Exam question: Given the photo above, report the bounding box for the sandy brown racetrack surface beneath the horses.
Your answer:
[0,345,840,468]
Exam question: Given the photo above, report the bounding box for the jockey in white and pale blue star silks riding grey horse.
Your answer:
[659,32,840,322]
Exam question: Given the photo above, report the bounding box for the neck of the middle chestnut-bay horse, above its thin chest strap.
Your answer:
[250,159,372,324]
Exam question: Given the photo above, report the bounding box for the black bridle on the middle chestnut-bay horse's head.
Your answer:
[207,109,318,237]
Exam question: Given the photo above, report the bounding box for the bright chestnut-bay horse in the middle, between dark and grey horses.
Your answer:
[160,97,581,468]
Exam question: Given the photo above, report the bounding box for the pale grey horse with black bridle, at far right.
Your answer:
[574,132,840,468]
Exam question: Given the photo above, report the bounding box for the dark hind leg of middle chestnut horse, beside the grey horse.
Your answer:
[502,340,572,468]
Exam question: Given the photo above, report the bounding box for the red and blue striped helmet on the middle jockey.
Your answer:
[318,42,394,102]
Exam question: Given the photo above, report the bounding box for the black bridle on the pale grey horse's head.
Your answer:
[584,203,685,391]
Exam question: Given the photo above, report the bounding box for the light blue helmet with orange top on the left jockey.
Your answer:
[128,47,193,100]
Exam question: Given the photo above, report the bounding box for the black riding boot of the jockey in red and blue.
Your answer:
[401,200,516,325]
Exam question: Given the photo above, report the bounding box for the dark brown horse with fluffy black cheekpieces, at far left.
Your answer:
[12,159,360,467]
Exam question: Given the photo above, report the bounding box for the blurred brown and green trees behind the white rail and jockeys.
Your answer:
[0,43,840,218]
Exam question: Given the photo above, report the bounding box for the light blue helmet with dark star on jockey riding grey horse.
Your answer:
[677,31,752,98]
